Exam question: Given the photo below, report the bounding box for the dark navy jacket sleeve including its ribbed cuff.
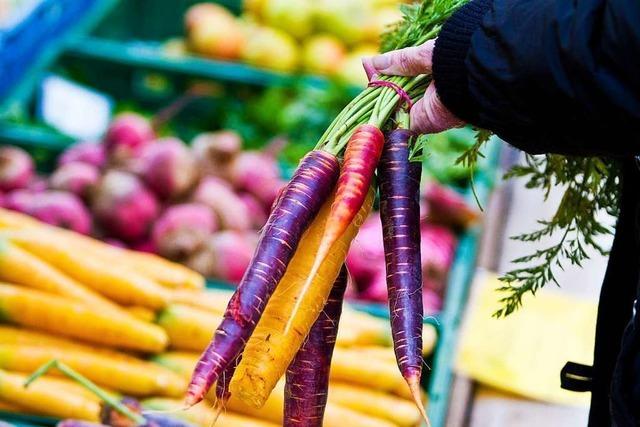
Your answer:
[433,0,640,156]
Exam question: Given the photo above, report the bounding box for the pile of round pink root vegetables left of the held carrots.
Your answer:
[0,113,283,283]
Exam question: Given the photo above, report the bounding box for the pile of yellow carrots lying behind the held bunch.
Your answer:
[0,209,435,427]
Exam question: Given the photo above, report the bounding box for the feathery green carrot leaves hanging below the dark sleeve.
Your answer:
[494,154,620,317]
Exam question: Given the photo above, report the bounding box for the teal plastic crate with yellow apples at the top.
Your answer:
[55,0,358,100]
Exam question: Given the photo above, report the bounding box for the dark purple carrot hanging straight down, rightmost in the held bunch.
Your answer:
[378,129,424,415]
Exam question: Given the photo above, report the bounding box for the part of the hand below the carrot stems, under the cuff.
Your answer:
[410,82,464,133]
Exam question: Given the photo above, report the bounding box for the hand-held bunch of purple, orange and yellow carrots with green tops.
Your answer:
[186,0,470,427]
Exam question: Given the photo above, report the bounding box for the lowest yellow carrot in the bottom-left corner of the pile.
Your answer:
[0,370,100,421]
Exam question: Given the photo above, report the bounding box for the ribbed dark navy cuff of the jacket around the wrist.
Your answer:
[433,0,493,122]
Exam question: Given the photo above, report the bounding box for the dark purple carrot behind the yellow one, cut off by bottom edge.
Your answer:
[282,266,348,427]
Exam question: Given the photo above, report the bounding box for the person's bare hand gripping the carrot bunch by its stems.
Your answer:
[362,40,464,133]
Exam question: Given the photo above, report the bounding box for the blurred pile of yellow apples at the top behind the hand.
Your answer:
[180,0,401,85]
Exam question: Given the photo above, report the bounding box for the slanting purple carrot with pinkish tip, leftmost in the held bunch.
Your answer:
[185,150,340,406]
